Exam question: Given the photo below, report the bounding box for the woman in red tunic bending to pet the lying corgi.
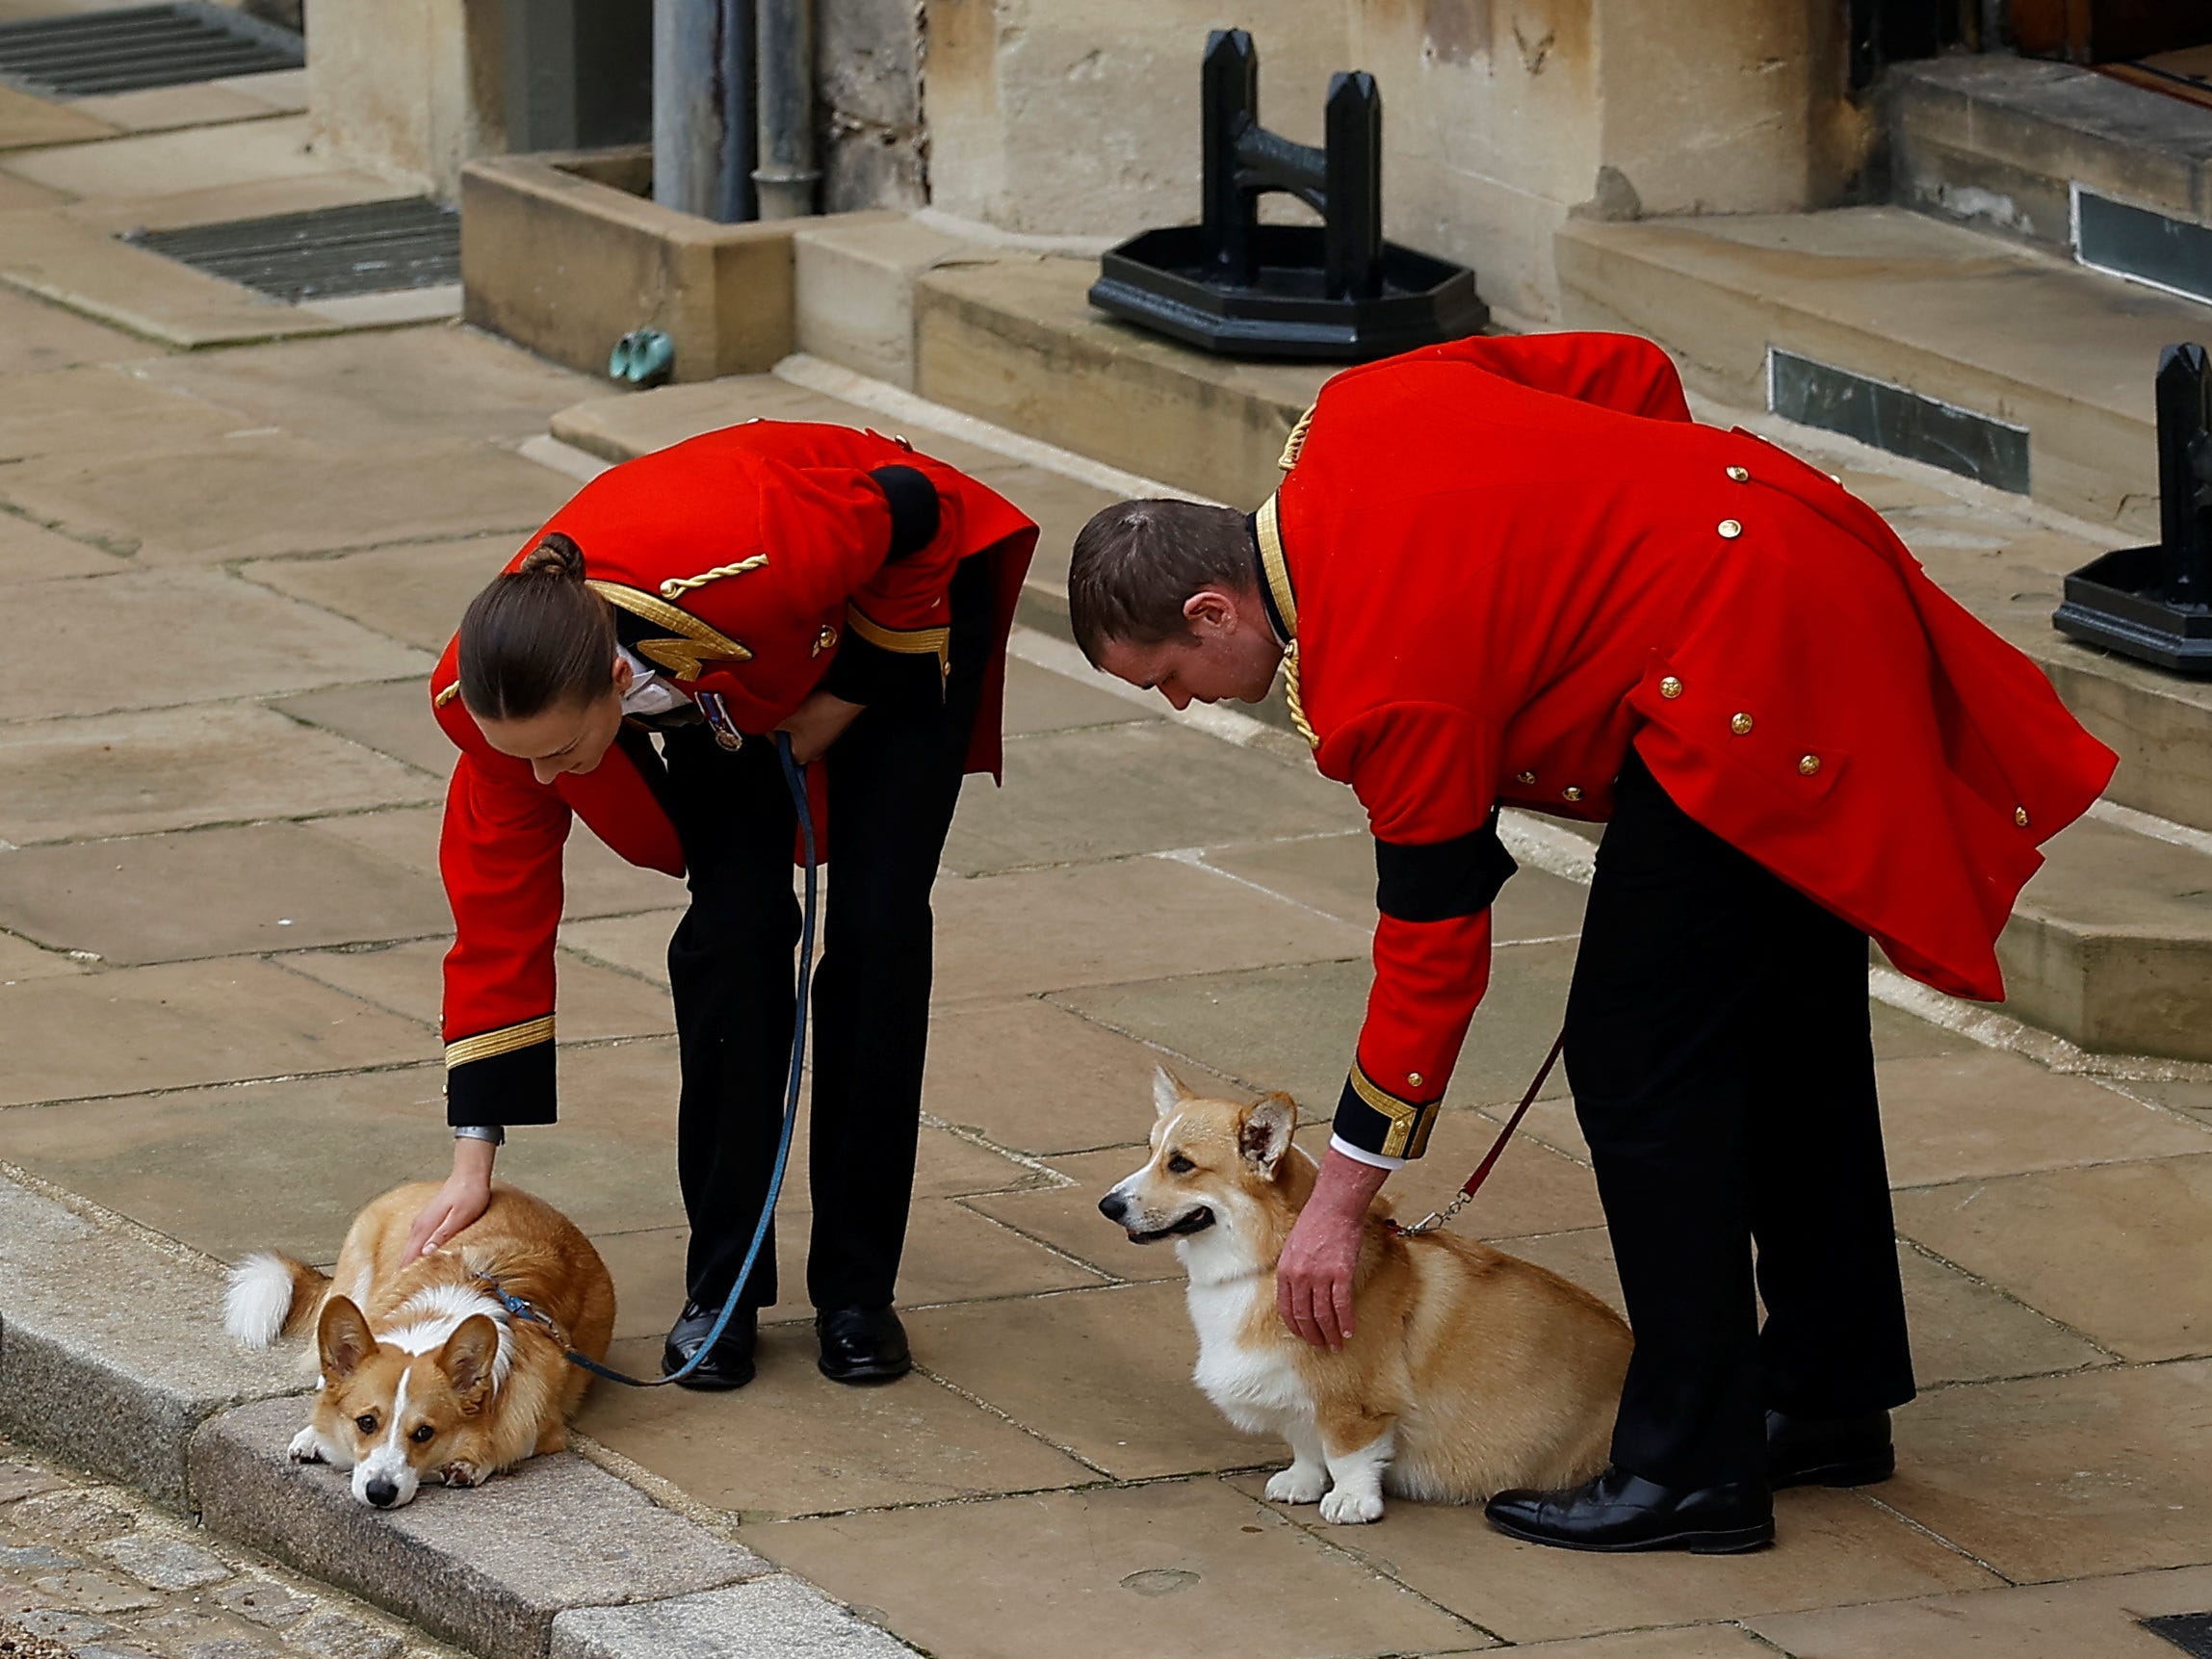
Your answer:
[411,420,1037,1389]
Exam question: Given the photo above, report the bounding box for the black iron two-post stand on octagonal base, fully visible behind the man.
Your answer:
[1090,29,1489,363]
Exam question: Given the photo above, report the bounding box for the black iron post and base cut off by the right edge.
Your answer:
[2050,345,2212,675]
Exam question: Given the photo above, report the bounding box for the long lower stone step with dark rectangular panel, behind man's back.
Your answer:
[1557,208,2212,540]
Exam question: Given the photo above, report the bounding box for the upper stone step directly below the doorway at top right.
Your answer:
[1883,53,2212,254]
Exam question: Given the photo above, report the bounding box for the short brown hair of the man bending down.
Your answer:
[1068,500,1259,668]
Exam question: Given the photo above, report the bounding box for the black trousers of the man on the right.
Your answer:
[1566,754,1913,1487]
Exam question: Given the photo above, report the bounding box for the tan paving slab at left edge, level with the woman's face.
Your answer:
[0,704,445,847]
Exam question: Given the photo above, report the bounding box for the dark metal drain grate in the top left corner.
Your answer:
[0,0,307,97]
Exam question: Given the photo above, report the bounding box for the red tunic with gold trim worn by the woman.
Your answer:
[431,420,1037,1124]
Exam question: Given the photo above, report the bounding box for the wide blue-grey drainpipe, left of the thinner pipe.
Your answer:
[653,0,754,223]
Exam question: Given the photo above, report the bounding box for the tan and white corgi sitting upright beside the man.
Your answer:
[1100,1071,1630,1522]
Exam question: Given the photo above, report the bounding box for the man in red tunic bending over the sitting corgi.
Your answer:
[1068,334,2115,1550]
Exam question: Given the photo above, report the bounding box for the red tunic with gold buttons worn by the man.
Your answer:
[1283,334,2115,1157]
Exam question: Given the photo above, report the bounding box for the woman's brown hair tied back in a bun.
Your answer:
[460,531,615,721]
